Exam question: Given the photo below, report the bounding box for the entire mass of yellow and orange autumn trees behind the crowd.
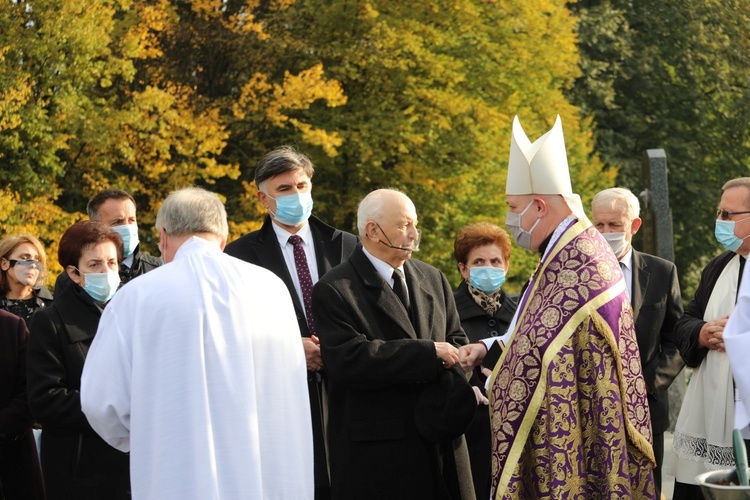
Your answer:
[0,0,614,288]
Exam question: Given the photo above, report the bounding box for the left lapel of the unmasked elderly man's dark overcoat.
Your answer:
[349,247,417,339]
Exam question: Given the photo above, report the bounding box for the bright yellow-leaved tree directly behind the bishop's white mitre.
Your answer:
[251,1,612,288]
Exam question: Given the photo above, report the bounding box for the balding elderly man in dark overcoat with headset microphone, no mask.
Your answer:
[313,189,477,500]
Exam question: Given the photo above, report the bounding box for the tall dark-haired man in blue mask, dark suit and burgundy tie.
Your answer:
[224,146,358,500]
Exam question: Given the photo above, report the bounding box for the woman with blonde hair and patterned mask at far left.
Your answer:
[0,234,52,323]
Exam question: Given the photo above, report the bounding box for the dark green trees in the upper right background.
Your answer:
[571,0,750,296]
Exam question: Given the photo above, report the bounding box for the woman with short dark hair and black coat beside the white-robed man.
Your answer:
[27,220,130,500]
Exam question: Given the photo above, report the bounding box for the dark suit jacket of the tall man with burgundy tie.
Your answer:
[224,216,359,488]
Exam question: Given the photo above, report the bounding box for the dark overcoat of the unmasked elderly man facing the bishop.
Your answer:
[313,247,473,500]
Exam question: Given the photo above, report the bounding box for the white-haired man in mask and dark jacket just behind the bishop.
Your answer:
[591,188,685,498]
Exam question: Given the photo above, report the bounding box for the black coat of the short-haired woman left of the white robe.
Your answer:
[26,282,130,500]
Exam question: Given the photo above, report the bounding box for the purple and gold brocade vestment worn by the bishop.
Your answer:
[489,220,655,499]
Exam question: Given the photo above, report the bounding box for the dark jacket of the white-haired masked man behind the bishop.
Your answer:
[631,250,685,434]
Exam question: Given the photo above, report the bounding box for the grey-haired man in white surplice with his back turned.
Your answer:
[81,188,313,500]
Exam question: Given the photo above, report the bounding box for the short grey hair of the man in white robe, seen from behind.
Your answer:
[156,187,229,239]
